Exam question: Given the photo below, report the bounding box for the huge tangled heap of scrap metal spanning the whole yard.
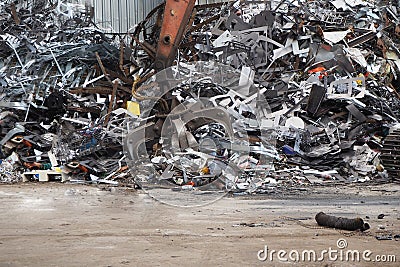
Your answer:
[0,0,400,192]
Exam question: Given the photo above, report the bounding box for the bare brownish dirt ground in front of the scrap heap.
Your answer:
[0,183,400,267]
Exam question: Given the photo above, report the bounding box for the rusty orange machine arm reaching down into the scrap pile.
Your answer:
[154,0,196,71]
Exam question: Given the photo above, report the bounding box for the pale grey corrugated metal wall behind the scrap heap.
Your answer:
[92,0,226,33]
